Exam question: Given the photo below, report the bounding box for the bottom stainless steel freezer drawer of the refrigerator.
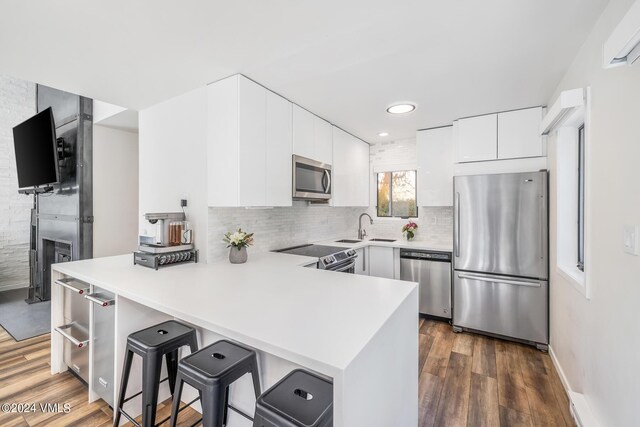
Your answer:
[453,271,549,344]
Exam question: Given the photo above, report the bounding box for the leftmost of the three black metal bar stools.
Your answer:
[113,320,198,427]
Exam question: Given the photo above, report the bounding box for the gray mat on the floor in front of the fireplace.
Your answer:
[0,288,51,341]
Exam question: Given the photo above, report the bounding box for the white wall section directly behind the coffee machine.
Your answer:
[138,87,209,260]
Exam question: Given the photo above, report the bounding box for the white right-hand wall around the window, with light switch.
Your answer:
[549,0,640,426]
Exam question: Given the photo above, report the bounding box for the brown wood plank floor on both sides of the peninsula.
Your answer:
[0,320,574,427]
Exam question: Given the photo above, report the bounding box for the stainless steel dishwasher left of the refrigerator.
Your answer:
[400,249,451,319]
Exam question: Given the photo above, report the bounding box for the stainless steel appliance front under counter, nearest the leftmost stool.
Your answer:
[88,287,116,407]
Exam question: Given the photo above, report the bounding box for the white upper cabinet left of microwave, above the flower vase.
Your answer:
[207,75,293,206]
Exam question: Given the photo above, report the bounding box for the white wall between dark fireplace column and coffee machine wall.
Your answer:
[93,125,138,258]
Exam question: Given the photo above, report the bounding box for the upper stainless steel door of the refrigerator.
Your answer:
[454,171,548,279]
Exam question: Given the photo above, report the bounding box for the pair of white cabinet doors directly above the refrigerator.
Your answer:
[455,107,546,163]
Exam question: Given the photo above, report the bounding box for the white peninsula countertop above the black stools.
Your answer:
[53,252,423,376]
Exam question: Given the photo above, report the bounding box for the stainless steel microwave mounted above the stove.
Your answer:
[293,154,331,201]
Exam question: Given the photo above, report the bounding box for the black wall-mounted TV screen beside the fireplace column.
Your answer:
[13,107,59,188]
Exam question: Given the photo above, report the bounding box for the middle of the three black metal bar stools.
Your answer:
[170,340,260,427]
